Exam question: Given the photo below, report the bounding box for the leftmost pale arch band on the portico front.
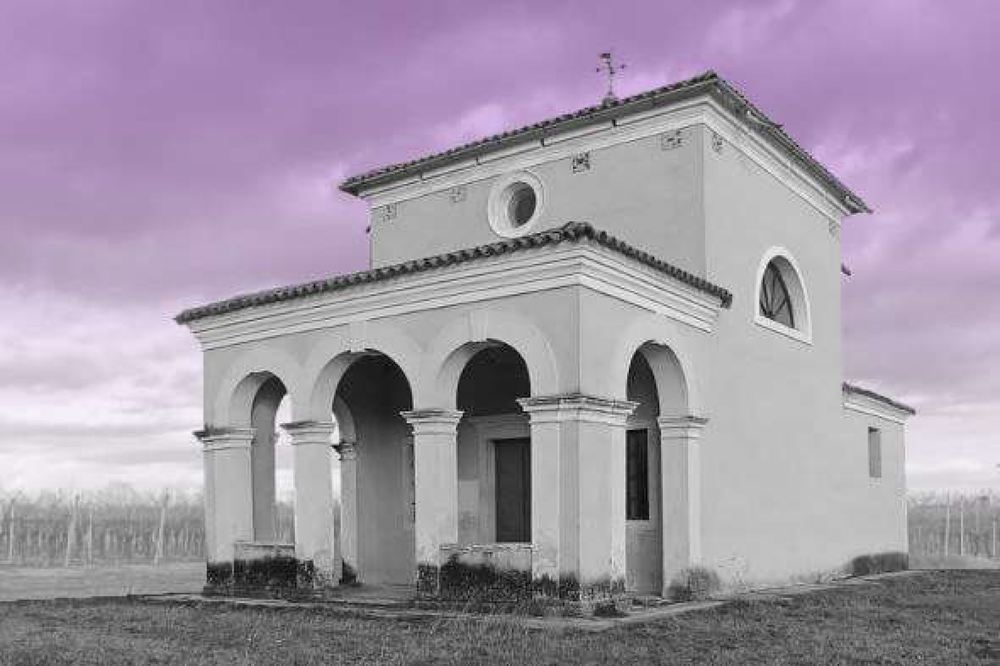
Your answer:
[213,349,301,428]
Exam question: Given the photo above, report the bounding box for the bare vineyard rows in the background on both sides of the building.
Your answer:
[0,485,1000,567]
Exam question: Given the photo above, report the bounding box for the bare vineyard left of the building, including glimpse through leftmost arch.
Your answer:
[0,485,294,567]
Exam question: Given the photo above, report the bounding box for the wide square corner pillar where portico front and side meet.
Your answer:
[519,394,636,600]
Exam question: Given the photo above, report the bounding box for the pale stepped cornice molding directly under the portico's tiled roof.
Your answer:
[188,243,722,350]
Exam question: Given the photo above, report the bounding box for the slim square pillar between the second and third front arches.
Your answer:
[401,409,462,594]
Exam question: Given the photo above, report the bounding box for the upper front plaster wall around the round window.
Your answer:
[371,126,704,275]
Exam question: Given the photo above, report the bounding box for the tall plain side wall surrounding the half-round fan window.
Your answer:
[701,123,905,583]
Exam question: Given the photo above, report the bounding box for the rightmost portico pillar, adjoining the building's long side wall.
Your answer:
[657,416,707,595]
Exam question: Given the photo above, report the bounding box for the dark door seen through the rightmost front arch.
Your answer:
[493,438,531,543]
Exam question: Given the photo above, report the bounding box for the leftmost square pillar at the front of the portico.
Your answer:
[194,428,254,591]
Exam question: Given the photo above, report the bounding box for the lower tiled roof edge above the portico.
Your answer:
[174,222,733,324]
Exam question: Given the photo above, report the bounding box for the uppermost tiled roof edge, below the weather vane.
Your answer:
[340,70,872,213]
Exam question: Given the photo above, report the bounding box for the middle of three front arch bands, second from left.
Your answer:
[292,325,421,421]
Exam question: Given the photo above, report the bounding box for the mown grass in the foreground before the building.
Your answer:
[0,571,1000,666]
